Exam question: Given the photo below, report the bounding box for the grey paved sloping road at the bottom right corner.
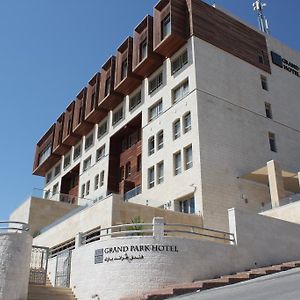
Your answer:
[171,268,300,300]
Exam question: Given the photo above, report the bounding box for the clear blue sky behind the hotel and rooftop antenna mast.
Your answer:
[0,0,300,220]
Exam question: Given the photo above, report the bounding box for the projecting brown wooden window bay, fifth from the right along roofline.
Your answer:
[85,73,108,124]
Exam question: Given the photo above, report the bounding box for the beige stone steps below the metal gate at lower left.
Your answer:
[27,278,76,300]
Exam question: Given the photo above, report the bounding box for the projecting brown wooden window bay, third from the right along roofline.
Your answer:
[115,37,142,95]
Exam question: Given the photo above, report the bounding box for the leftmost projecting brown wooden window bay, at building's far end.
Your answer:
[33,124,60,176]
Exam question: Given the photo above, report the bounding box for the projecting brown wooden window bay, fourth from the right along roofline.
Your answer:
[98,56,124,111]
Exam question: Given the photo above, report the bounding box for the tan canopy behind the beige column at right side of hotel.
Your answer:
[240,166,299,193]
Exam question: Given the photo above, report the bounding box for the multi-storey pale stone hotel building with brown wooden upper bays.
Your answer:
[29,0,300,229]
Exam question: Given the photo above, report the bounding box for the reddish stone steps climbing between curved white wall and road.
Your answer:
[121,261,300,300]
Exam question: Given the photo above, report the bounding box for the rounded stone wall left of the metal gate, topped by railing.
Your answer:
[0,233,32,300]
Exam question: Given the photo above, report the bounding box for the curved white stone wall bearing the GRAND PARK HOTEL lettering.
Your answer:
[67,209,300,300]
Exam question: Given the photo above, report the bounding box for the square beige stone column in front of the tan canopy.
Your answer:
[267,160,286,208]
